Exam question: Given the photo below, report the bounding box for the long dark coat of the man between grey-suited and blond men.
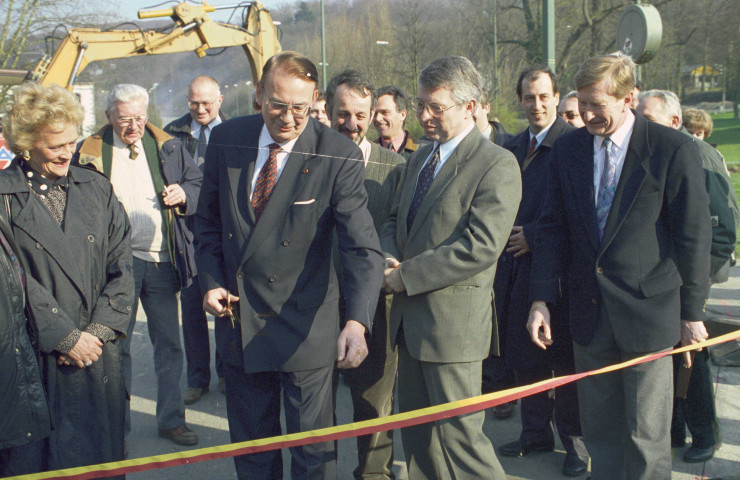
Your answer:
[493,117,574,369]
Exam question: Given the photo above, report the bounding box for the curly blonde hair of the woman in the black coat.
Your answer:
[3,83,84,154]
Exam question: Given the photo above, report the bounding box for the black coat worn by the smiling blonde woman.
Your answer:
[0,160,134,469]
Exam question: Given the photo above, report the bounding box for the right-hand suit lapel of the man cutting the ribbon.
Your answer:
[240,126,316,265]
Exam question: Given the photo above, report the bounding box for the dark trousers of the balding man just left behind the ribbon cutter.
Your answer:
[180,275,224,388]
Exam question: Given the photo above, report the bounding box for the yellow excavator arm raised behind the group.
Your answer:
[29,1,280,90]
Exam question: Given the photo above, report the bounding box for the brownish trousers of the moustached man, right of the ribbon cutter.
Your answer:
[345,295,398,480]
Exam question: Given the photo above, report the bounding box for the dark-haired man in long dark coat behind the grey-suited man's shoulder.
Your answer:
[493,65,587,477]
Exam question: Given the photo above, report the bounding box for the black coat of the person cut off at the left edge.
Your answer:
[0,205,51,450]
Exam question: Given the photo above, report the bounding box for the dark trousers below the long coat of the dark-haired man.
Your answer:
[515,365,587,456]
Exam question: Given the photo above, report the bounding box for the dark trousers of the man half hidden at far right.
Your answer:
[671,348,722,448]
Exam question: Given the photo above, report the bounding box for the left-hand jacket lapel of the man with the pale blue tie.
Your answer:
[564,129,599,251]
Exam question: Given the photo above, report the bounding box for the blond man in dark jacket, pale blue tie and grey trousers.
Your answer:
[527,55,711,480]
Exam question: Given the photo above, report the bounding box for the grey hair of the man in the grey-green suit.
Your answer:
[419,57,483,105]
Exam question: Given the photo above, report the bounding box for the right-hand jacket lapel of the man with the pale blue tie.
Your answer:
[601,115,651,250]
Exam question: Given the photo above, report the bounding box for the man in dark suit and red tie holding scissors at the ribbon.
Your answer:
[196,51,383,480]
